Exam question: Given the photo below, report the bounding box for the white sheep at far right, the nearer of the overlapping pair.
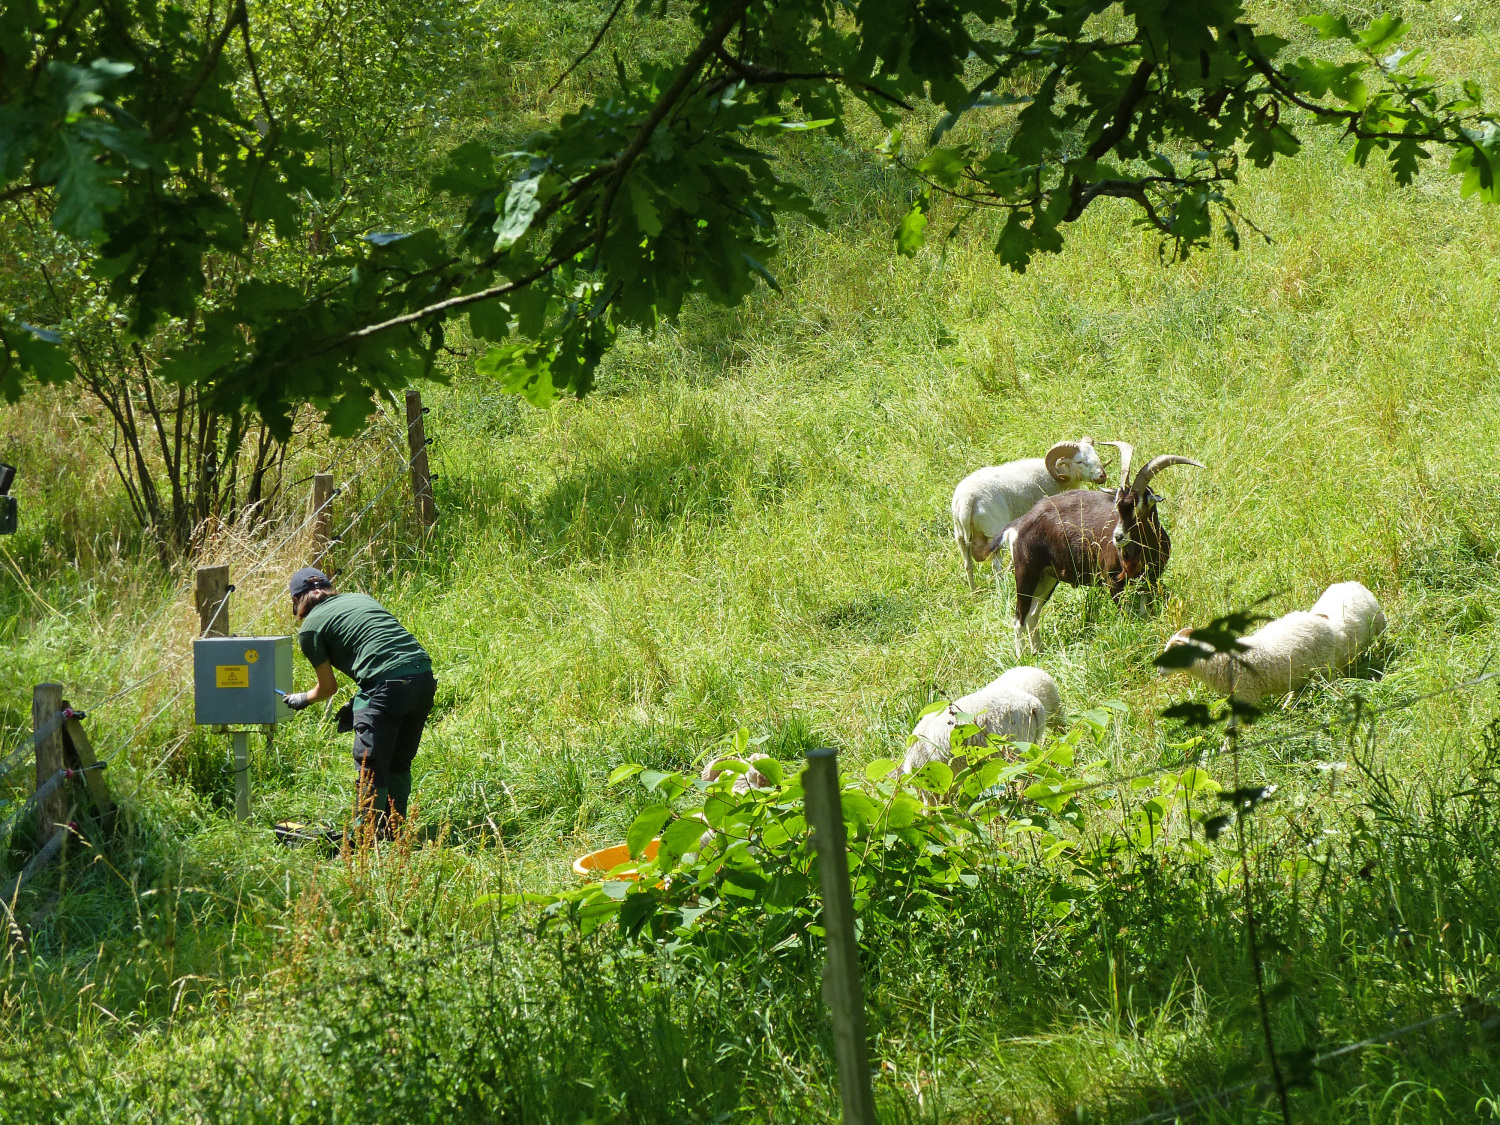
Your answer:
[1167,609,1343,704]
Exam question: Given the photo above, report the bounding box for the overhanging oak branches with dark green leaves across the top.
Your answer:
[0,0,1500,437]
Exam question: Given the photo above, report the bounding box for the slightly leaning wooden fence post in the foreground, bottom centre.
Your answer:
[803,747,875,1125]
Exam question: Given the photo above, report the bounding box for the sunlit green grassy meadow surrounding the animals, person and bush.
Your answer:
[0,0,1500,1125]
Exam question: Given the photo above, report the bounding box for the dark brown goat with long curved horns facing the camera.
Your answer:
[989,441,1205,656]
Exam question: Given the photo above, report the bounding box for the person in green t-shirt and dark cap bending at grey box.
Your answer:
[287,567,438,839]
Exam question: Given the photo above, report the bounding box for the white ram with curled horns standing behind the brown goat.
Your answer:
[953,438,1107,590]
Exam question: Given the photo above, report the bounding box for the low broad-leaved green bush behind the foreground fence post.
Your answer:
[504,701,1221,957]
